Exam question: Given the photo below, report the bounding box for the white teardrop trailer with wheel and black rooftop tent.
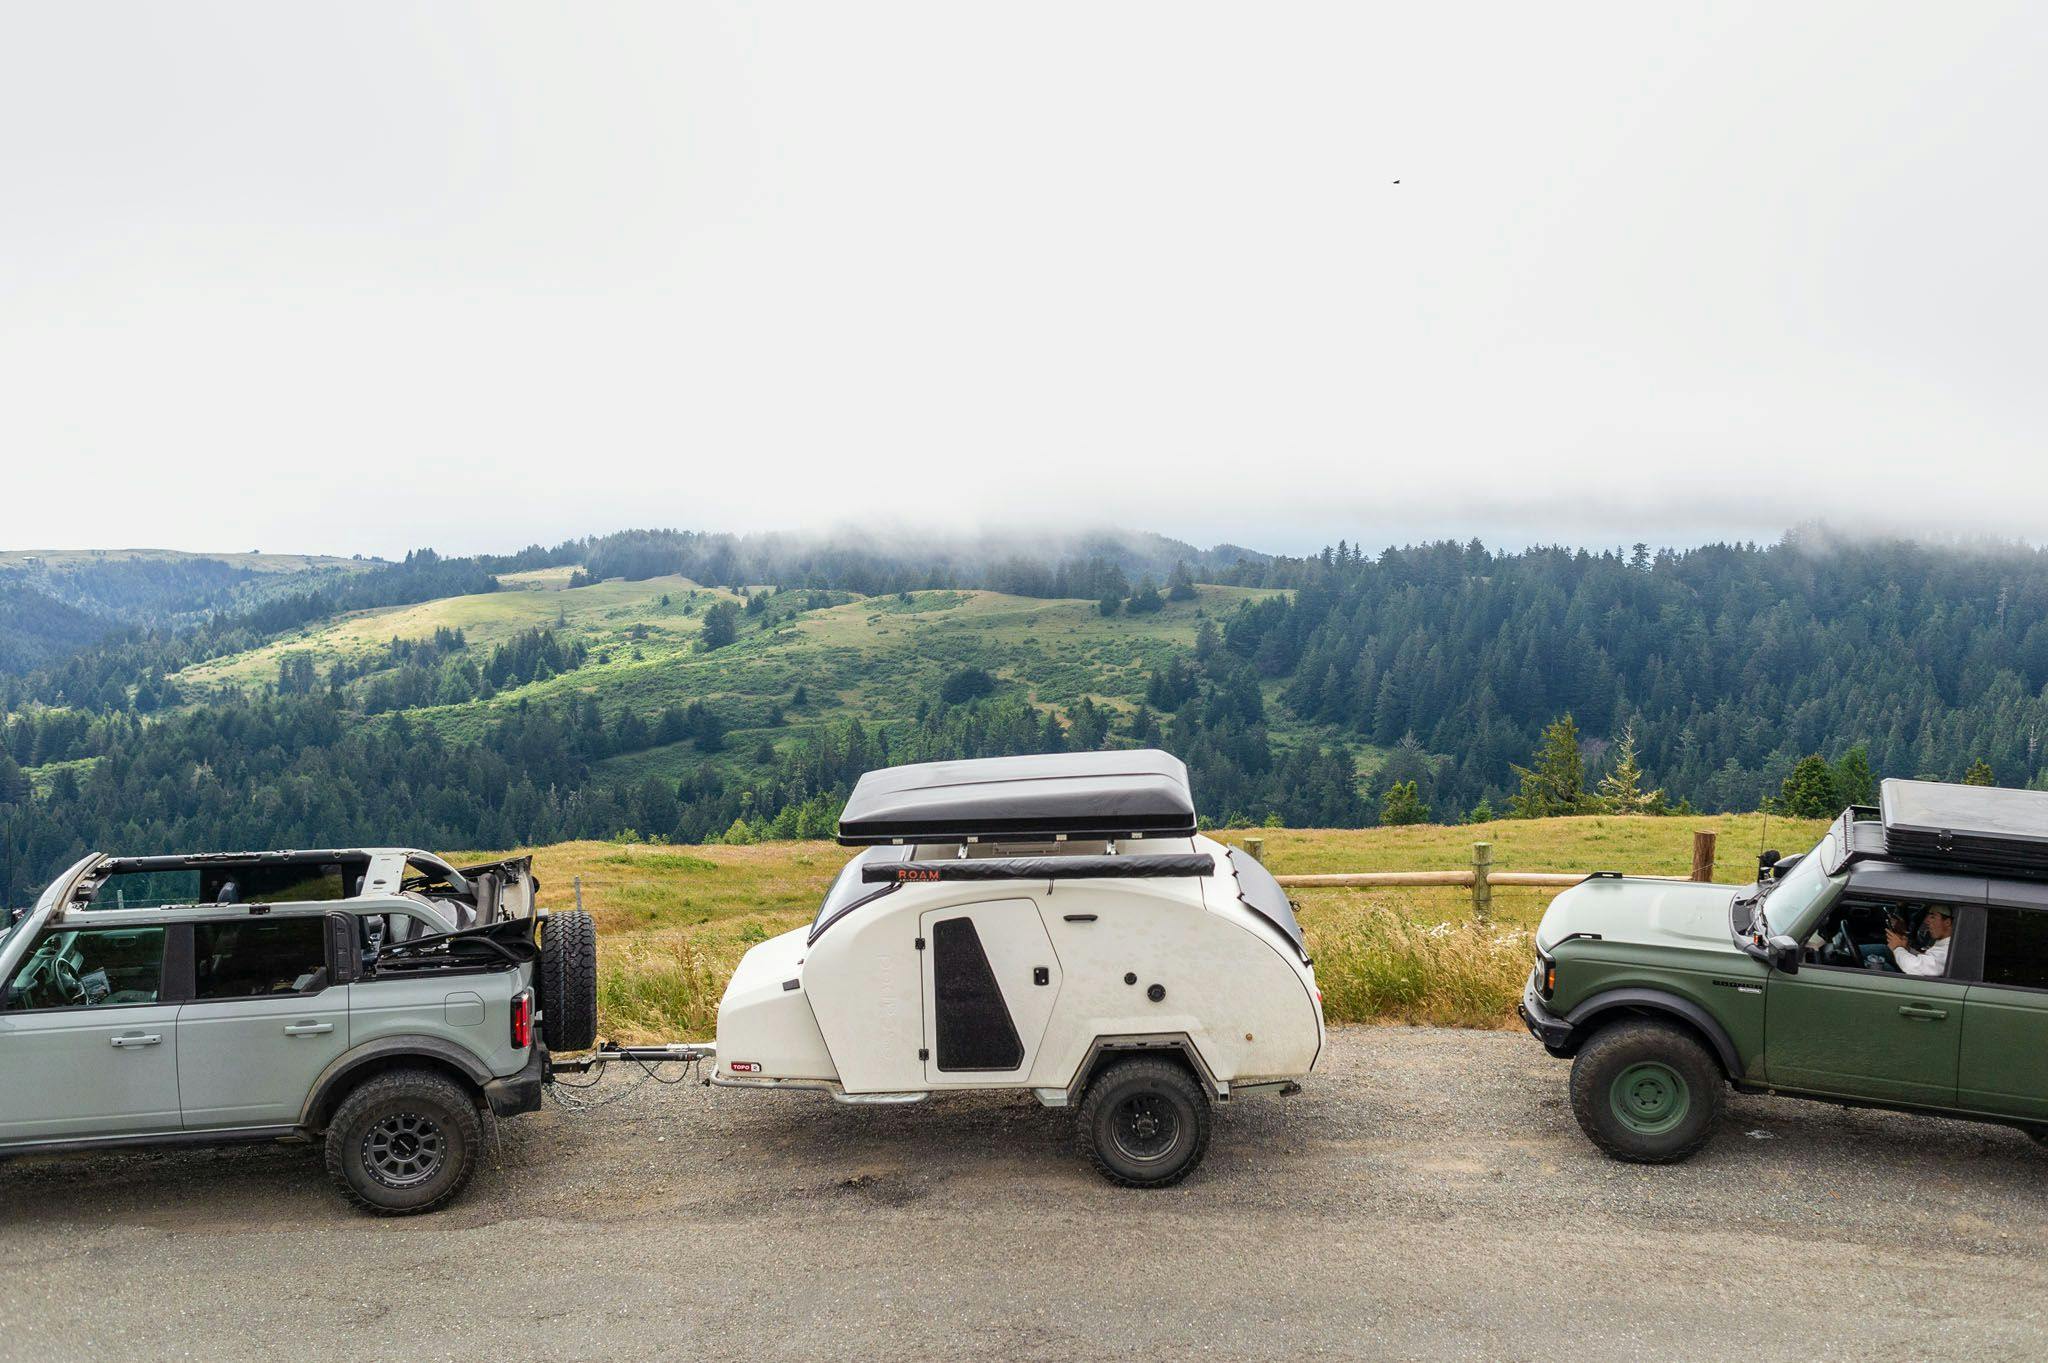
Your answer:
[659,749,1323,1187]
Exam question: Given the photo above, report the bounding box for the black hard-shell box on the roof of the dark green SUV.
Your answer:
[1878,778,2048,880]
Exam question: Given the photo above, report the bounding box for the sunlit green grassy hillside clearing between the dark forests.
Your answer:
[172,567,1276,780]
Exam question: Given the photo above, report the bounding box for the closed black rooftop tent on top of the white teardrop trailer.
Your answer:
[840,747,1194,847]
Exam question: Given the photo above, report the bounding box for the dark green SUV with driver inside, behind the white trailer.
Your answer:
[1520,780,2048,1162]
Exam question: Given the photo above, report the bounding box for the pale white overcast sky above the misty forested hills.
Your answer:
[0,0,2048,555]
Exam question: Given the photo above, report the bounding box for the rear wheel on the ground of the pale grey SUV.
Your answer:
[328,1070,483,1216]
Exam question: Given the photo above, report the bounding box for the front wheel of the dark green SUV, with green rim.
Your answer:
[1571,1019,1729,1164]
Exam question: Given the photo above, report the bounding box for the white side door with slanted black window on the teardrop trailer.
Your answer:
[918,898,1059,1087]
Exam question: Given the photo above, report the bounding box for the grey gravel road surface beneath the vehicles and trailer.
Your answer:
[0,1027,2048,1363]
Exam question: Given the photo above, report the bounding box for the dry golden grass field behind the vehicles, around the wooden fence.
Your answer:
[487,815,1823,1040]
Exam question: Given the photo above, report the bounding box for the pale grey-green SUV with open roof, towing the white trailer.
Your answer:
[0,847,596,1214]
